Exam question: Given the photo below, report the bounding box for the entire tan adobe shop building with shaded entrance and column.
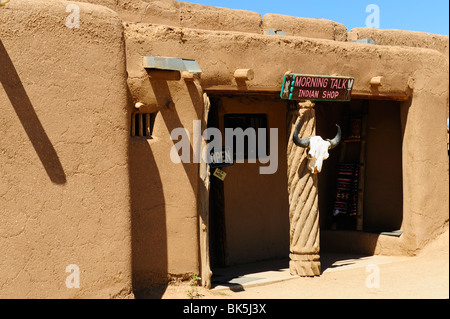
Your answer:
[0,0,449,298]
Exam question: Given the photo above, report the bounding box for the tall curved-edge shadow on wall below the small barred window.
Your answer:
[128,137,168,298]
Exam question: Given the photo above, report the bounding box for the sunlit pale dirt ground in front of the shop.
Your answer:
[153,230,449,299]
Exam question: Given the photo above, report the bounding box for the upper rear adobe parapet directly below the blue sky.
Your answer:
[75,0,347,41]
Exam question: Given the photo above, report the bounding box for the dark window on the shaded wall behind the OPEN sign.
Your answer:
[224,114,269,160]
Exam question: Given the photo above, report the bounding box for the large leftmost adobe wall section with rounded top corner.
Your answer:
[0,0,131,298]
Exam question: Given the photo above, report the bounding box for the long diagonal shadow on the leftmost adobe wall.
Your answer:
[0,40,66,184]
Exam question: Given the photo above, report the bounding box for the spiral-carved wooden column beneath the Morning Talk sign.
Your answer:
[287,102,320,276]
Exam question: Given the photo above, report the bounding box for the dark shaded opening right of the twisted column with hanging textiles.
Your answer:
[316,99,403,233]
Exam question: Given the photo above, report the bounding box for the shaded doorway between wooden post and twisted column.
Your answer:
[208,94,289,273]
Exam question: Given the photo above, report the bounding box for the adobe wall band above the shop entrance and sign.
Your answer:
[125,23,447,94]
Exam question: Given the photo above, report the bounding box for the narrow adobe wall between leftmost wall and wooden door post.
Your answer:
[127,74,203,289]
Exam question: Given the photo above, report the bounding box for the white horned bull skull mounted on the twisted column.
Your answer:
[293,122,341,174]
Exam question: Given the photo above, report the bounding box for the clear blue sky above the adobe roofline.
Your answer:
[185,0,449,35]
